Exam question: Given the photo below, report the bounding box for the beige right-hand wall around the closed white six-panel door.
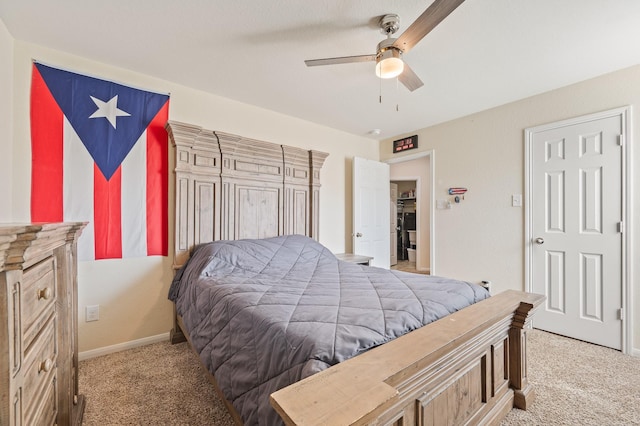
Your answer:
[380,65,640,350]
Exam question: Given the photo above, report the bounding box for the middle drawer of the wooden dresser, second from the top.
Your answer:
[22,313,58,424]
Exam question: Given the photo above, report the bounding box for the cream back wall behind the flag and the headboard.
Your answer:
[10,40,379,352]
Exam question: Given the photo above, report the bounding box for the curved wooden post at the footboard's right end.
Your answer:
[509,302,535,410]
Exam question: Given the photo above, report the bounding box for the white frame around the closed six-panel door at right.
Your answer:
[524,105,635,354]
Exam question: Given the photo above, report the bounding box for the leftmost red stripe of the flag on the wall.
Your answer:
[30,64,64,222]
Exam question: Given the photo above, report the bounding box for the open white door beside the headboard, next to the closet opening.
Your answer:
[353,157,391,269]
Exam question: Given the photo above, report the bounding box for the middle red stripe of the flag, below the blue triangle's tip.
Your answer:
[93,165,122,259]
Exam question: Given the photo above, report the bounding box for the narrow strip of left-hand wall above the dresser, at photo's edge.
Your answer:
[0,20,13,222]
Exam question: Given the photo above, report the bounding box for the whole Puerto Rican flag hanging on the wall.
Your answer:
[31,63,169,260]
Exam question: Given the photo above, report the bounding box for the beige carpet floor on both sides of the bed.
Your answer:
[79,330,640,426]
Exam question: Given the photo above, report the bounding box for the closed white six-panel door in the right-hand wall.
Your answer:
[527,111,623,349]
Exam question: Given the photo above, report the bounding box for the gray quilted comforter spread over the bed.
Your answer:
[169,235,488,425]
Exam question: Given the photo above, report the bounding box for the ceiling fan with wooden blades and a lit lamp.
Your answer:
[304,0,464,92]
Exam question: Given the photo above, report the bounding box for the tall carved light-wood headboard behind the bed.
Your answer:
[166,121,329,268]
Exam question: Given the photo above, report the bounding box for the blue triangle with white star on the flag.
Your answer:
[35,63,169,180]
